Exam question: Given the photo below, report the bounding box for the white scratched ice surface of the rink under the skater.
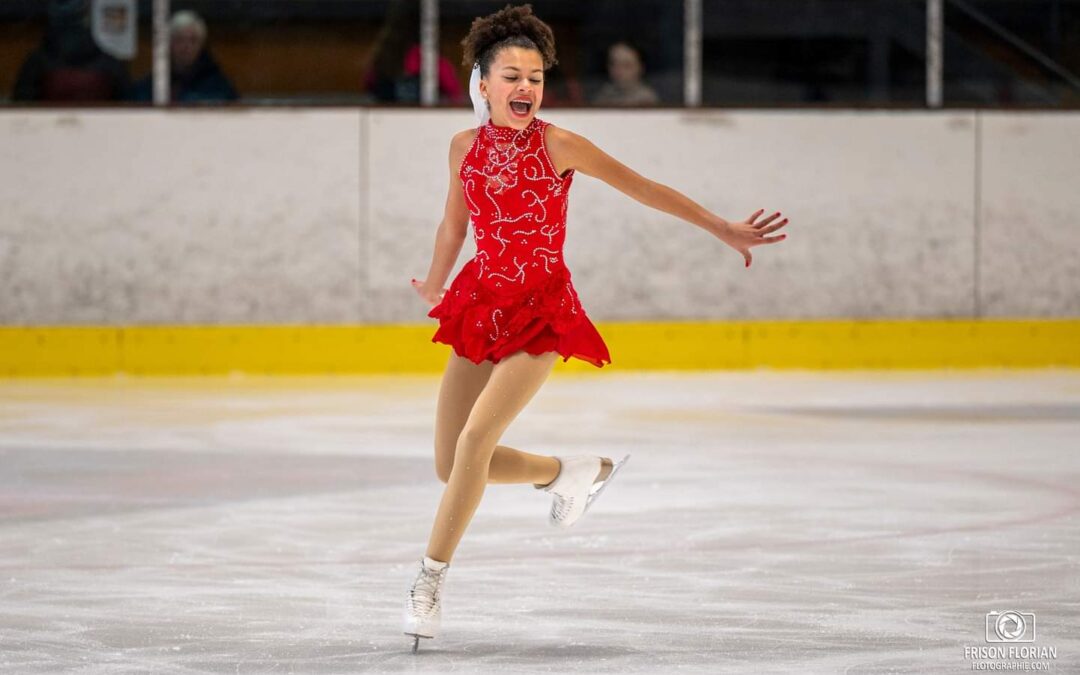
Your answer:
[0,365,1080,674]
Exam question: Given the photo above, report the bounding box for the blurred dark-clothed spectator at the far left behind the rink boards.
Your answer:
[11,0,130,103]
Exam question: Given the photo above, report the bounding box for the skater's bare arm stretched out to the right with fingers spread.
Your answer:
[545,125,787,267]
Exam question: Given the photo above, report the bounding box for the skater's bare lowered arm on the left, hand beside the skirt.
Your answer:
[413,129,476,306]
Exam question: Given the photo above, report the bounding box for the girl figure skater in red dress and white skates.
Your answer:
[405,4,787,652]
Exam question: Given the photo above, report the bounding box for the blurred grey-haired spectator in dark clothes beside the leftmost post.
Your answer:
[130,11,238,103]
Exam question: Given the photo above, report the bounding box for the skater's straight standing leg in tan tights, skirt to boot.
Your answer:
[427,351,558,563]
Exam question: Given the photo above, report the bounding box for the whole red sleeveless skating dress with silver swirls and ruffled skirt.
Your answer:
[428,117,611,367]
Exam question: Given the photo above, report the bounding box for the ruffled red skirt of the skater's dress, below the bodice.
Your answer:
[428,258,611,368]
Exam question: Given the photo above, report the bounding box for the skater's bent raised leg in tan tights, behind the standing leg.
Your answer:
[435,351,558,485]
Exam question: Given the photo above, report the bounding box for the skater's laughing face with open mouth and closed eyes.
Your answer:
[480,46,543,129]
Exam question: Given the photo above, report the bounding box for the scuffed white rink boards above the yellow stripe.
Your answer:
[0,109,1080,325]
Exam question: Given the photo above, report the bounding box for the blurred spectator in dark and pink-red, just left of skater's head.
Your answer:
[361,0,467,104]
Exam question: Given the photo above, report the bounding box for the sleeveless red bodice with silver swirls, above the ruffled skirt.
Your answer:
[458,117,573,294]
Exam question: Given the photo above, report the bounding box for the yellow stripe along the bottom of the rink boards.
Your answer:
[0,319,1080,377]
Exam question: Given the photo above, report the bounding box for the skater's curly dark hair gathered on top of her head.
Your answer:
[461,3,558,76]
